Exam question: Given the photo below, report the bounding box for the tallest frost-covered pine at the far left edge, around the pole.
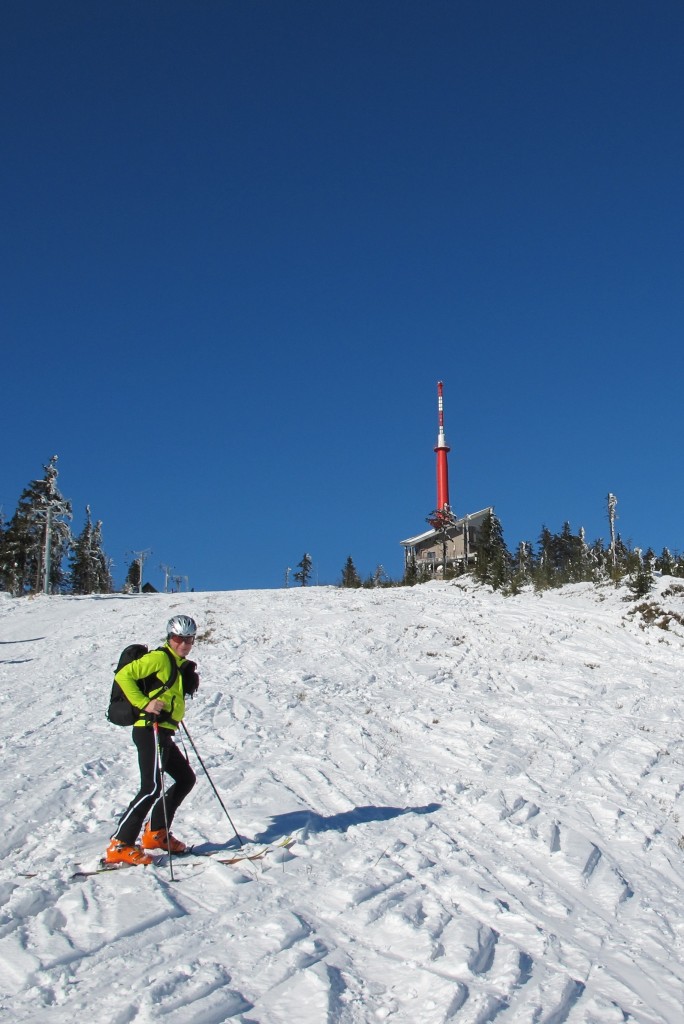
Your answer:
[0,455,73,596]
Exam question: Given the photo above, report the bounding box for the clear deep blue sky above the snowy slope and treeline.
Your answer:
[0,0,684,590]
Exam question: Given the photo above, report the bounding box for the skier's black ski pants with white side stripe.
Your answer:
[113,726,197,846]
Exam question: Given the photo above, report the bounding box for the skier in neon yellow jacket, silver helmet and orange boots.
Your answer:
[104,615,200,864]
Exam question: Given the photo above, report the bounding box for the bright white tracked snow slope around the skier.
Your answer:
[0,579,684,1024]
